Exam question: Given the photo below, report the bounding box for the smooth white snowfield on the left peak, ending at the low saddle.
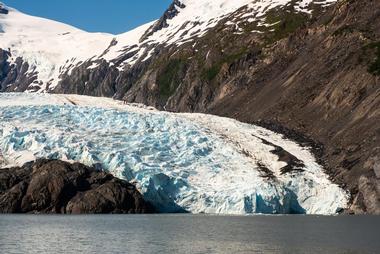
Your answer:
[0,5,113,90]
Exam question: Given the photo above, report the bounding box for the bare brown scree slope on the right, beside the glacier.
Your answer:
[211,1,380,213]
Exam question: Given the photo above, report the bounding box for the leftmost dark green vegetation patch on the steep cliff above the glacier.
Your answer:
[157,59,186,99]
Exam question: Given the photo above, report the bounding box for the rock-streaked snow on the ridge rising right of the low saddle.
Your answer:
[87,0,337,66]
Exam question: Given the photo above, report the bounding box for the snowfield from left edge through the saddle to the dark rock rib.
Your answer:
[0,3,156,92]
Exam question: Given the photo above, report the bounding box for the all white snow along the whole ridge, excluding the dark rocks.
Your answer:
[0,0,336,91]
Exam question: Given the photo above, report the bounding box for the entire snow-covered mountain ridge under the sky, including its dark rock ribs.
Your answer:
[0,0,335,91]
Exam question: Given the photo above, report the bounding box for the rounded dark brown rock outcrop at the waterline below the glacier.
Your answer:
[0,160,153,214]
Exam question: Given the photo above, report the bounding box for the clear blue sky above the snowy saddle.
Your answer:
[0,0,172,34]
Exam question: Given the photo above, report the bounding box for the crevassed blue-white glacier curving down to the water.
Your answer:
[0,93,349,214]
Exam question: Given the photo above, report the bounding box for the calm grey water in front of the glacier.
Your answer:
[0,215,380,254]
